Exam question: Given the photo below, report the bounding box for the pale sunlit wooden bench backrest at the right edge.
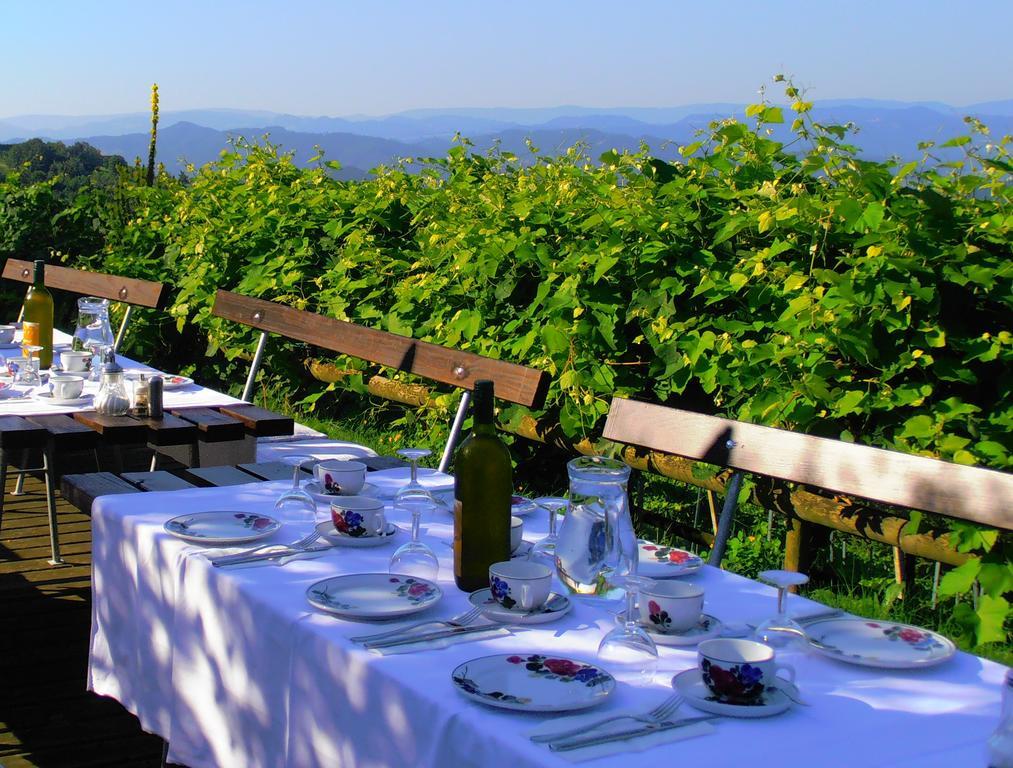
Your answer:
[604,397,1013,529]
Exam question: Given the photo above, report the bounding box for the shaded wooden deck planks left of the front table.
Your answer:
[0,478,162,768]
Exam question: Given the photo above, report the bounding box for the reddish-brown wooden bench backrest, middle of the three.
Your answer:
[212,291,549,408]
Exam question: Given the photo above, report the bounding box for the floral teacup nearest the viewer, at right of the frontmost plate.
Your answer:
[697,638,795,704]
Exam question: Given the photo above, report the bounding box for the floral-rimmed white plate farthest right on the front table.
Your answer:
[805,618,956,670]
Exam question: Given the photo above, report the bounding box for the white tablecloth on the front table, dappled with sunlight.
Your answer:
[88,483,1005,768]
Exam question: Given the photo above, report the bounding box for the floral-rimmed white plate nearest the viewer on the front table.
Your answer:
[451,654,616,712]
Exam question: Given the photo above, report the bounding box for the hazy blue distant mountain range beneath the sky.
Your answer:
[0,99,1013,178]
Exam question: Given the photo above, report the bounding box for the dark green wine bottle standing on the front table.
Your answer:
[454,380,514,592]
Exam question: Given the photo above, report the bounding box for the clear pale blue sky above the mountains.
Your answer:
[0,0,1013,118]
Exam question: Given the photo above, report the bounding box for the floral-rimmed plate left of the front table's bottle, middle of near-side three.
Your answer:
[306,573,443,619]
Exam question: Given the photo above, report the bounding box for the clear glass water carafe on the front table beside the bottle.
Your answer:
[556,456,637,599]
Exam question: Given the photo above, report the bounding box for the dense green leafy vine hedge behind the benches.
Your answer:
[0,79,1013,644]
